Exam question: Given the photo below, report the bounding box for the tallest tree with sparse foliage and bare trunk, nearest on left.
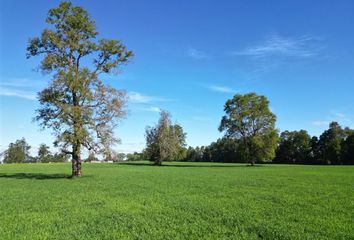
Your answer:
[27,2,133,176]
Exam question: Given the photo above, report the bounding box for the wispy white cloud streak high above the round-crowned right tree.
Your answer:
[233,35,321,58]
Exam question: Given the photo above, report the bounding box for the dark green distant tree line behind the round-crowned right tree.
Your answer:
[184,122,354,165]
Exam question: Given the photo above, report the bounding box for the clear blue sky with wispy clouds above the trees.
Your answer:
[0,0,354,152]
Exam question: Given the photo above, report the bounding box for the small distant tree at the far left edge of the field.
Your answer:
[2,138,33,163]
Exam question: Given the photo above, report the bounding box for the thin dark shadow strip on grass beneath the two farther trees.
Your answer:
[119,162,262,168]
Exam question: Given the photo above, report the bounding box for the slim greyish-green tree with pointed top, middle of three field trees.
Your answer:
[145,111,186,165]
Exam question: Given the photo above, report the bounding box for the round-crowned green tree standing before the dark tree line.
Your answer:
[219,93,278,165]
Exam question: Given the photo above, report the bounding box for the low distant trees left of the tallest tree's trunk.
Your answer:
[1,138,68,163]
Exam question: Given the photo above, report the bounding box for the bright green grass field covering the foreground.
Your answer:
[0,162,354,240]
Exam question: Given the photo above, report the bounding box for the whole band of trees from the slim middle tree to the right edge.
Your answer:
[142,93,354,165]
